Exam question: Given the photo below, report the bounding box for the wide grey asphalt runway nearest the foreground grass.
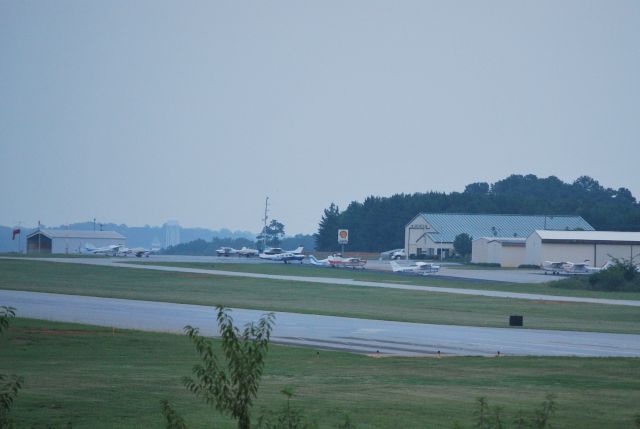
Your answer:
[0,290,640,357]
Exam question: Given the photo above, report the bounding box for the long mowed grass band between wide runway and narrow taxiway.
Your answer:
[0,260,640,334]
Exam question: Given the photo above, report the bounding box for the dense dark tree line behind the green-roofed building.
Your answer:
[314,174,640,252]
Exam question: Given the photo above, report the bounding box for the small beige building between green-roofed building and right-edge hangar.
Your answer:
[471,237,527,267]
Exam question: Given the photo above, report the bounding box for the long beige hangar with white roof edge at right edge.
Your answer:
[525,230,640,267]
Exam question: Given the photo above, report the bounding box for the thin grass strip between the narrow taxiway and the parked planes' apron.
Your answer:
[125,261,640,300]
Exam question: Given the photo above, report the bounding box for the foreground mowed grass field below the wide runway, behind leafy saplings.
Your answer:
[0,318,640,429]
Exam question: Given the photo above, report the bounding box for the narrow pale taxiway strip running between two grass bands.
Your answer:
[16,258,640,307]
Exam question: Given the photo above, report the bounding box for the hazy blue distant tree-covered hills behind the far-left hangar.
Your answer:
[0,222,256,252]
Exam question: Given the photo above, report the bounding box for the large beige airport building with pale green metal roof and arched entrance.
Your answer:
[404,213,593,258]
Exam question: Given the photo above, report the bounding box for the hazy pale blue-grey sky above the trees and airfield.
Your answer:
[0,0,640,234]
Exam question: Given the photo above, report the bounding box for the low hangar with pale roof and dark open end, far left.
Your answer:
[27,229,127,254]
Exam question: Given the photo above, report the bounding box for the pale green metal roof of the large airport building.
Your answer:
[419,213,594,243]
